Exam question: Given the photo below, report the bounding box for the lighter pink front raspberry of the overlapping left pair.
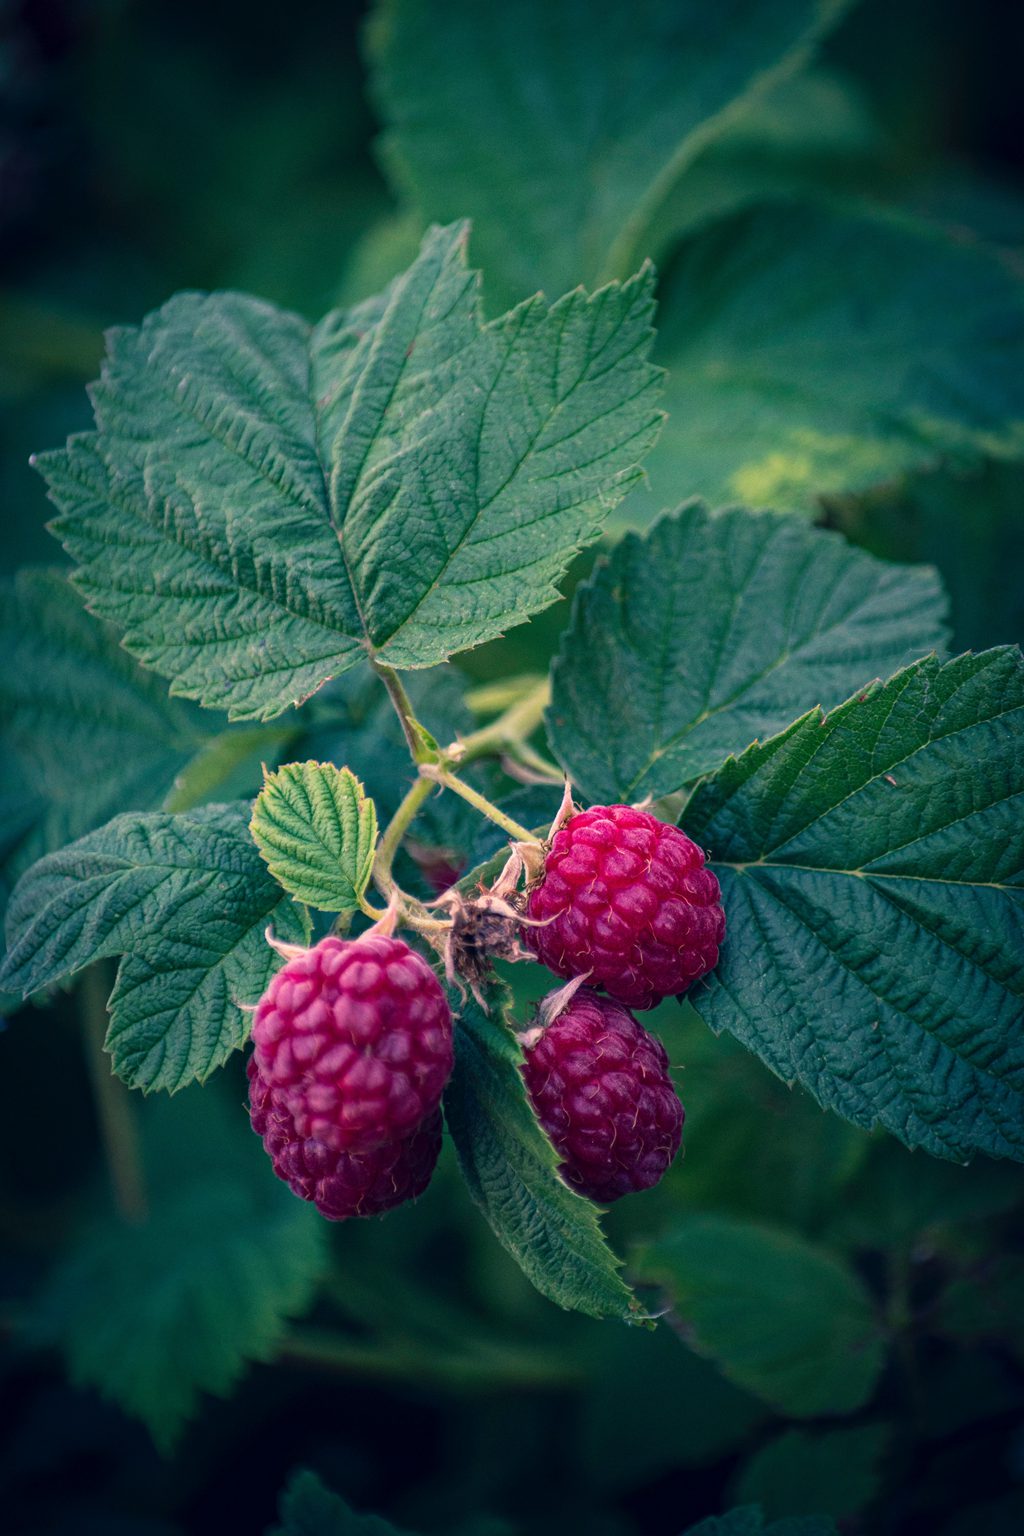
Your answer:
[252,934,453,1154]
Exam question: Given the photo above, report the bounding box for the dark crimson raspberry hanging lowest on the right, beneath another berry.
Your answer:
[522,988,685,1201]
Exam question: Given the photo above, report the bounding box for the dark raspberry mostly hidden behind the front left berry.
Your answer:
[247,1057,441,1221]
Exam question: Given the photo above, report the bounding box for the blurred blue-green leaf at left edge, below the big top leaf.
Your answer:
[0,570,216,915]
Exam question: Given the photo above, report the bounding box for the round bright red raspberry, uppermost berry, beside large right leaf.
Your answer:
[524,805,725,1008]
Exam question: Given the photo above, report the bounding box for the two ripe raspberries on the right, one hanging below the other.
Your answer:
[522,805,725,1201]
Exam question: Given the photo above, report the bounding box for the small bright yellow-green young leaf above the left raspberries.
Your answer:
[249,763,376,912]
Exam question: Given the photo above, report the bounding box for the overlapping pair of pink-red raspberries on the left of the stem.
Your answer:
[249,932,453,1221]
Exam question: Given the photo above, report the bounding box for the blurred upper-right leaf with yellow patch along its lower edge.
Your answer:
[623,206,1024,521]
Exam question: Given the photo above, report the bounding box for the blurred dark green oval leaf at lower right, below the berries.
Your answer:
[633,1215,883,1418]
